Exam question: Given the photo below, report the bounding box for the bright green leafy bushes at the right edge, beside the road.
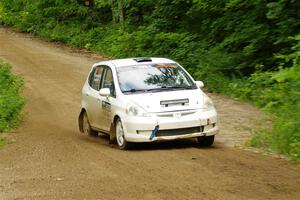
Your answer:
[245,35,300,161]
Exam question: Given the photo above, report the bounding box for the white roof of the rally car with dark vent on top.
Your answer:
[95,57,175,68]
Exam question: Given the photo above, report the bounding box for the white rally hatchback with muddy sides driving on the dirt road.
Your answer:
[79,58,218,149]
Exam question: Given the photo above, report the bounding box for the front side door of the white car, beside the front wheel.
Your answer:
[99,67,116,131]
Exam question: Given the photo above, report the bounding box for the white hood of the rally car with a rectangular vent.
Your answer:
[126,89,205,113]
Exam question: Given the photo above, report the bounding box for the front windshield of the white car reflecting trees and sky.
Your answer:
[117,63,197,93]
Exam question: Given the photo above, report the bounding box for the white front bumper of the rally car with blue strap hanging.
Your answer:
[122,109,219,142]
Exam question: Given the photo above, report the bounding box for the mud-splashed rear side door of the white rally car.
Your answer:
[85,66,104,129]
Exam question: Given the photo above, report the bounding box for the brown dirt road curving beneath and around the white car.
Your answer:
[0,28,300,200]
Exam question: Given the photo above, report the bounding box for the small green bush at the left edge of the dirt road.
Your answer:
[0,62,24,133]
